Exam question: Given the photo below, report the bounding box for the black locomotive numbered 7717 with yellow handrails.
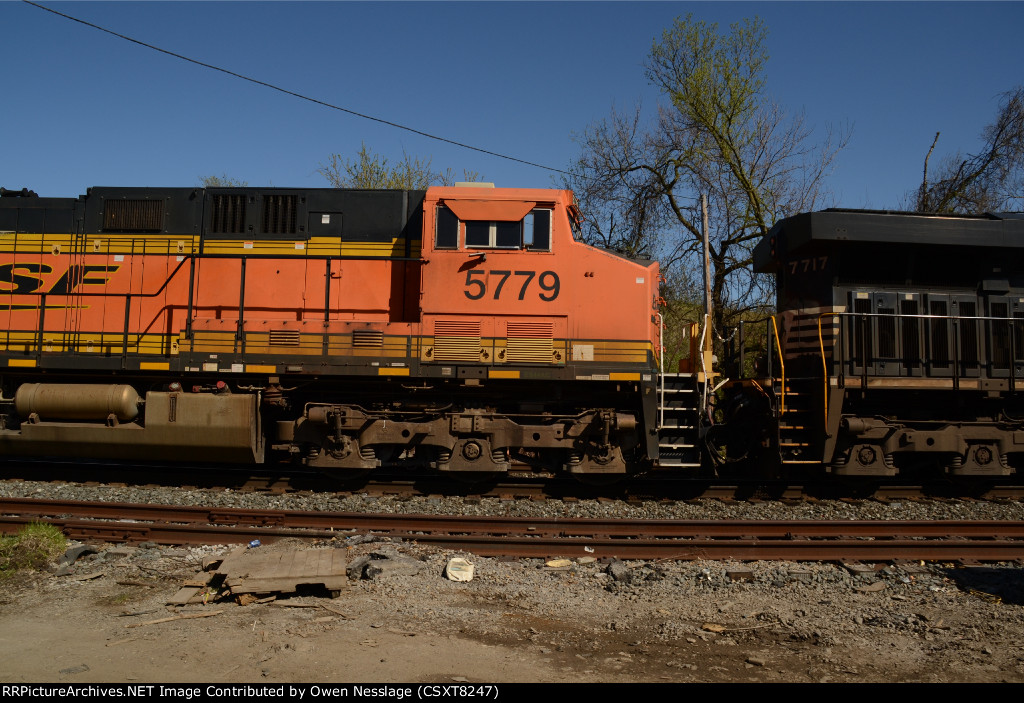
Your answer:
[729,210,1024,477]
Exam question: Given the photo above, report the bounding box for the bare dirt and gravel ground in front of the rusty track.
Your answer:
[0,542,1024,684]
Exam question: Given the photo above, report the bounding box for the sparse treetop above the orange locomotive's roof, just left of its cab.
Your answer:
[316,143,480,190]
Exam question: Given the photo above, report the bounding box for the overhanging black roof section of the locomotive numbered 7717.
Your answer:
[754,208,1024,273]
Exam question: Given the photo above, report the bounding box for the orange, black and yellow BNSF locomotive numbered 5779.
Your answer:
[0,184,696,475]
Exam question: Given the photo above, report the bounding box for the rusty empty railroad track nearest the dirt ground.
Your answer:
[0,498,1024,562]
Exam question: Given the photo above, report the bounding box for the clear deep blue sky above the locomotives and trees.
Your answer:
[0,1,1024,208]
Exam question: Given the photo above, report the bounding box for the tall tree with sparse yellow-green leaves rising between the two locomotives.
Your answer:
[566,16,849,366]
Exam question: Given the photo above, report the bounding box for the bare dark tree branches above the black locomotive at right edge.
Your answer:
[913,86,1024,214]
